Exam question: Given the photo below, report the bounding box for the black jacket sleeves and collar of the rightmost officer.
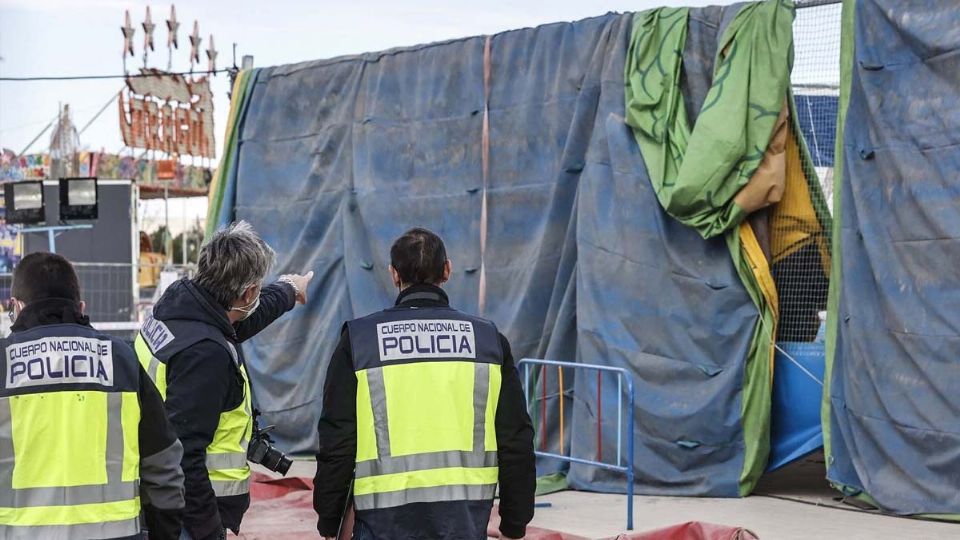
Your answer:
[313,285,536,538]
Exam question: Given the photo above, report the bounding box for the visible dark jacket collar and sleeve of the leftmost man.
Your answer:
[11,298,183,540]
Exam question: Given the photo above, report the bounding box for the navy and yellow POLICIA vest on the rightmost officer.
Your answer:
[348,308,503,512]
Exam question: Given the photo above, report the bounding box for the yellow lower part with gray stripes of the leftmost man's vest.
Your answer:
[0,390,140,538]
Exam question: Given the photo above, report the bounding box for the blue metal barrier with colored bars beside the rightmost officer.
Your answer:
[517,358,634,531]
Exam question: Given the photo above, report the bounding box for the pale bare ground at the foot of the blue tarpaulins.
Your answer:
[272,456,960,540]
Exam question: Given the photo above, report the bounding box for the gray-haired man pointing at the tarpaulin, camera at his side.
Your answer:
[135,221,313,540]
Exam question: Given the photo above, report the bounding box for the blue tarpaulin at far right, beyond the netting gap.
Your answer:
[824,0,960,514]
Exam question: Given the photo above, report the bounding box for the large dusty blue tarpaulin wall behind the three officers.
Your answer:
[220,7,788,496]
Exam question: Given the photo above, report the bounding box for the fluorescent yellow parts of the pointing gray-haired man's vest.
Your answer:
[134,327,253,497]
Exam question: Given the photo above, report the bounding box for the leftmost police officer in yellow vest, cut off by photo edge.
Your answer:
[0,253,183,539]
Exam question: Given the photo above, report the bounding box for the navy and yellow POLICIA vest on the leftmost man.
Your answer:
[0,324,140,539]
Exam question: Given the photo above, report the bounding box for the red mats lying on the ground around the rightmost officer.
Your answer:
[240,473,757,540]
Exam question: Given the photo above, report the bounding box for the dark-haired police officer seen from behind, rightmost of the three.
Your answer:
[314,228,536,540]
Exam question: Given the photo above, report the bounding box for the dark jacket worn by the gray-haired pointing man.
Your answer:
[153,279,295,540]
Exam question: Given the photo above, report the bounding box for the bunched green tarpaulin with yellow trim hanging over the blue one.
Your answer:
[625,0,826,495]
